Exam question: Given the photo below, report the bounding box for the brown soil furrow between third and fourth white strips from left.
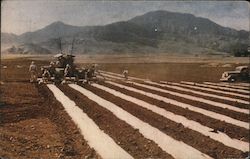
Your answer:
[101,83,249,142]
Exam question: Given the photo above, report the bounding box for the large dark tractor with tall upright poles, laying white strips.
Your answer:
[38,39,100,84]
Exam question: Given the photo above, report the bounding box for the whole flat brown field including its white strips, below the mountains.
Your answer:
[0,57,250,159]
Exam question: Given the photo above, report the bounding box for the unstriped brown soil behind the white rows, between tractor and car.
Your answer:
[96,63,238,82]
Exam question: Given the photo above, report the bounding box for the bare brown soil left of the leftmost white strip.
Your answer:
[0,59,100,159]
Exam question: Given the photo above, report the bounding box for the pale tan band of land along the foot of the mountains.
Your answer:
[1,54,249,64]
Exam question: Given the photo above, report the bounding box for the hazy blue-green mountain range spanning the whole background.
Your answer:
[3,11,249,54]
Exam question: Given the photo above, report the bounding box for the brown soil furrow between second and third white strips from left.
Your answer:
[84,85,245,158]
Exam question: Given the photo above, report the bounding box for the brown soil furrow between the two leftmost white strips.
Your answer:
[59,86,172,158]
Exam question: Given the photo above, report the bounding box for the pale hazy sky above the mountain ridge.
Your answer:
[1,0,250,35]
